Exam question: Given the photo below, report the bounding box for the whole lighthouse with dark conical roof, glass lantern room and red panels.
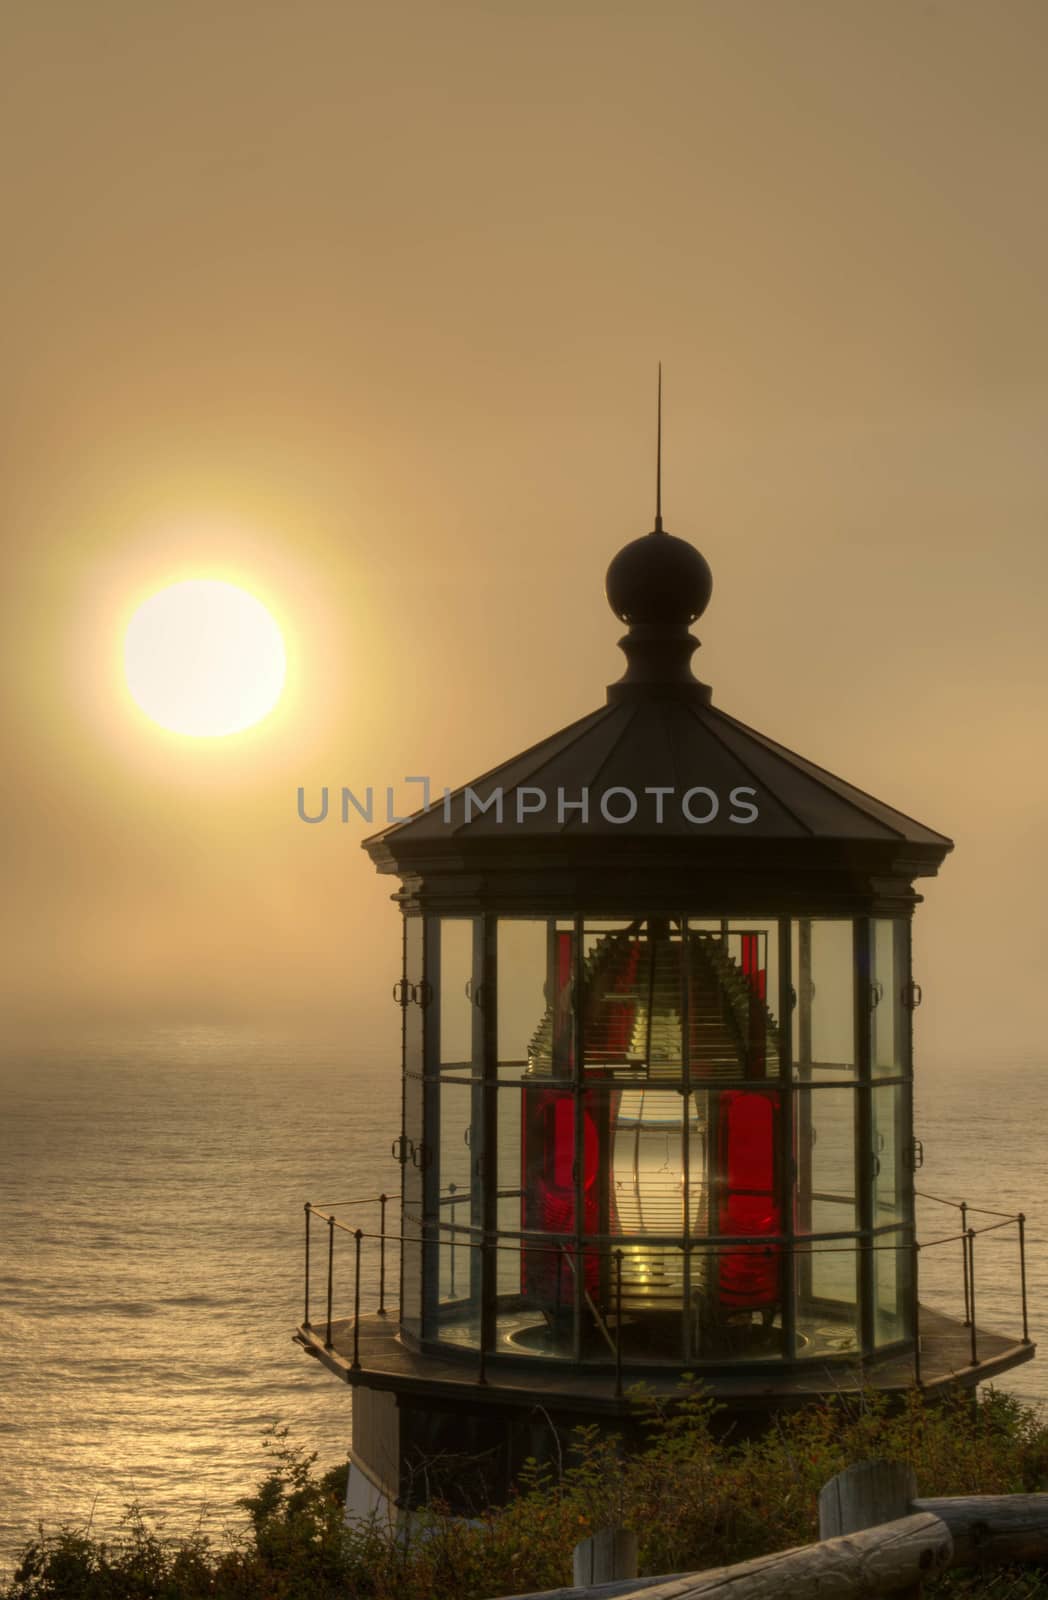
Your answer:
[298,460,1034,1515]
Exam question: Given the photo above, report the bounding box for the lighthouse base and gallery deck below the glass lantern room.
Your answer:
[298,1306,1035,1530]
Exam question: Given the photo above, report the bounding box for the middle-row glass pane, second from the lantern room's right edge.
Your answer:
[795,1088,856,1234]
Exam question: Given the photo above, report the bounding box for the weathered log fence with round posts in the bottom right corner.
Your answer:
[489,1462,1048,1600]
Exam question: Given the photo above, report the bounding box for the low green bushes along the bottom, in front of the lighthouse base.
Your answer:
[0,1384,1048,1600]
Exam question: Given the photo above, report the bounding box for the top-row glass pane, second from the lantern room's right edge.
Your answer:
[790,917,856,1078]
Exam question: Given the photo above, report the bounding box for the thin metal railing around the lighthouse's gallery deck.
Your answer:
[302,1190,1030,1398]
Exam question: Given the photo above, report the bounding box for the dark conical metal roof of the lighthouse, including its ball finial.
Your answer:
[365,515,952,902]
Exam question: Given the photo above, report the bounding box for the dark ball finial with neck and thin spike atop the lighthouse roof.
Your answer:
[605,371,714,698]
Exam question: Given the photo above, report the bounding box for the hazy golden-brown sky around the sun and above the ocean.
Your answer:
[0,0,1048,1059]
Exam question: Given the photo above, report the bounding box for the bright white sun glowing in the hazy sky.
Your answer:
[123,578,286,739]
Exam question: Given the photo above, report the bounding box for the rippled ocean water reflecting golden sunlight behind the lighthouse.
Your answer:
[0,1027,1048,1565]
